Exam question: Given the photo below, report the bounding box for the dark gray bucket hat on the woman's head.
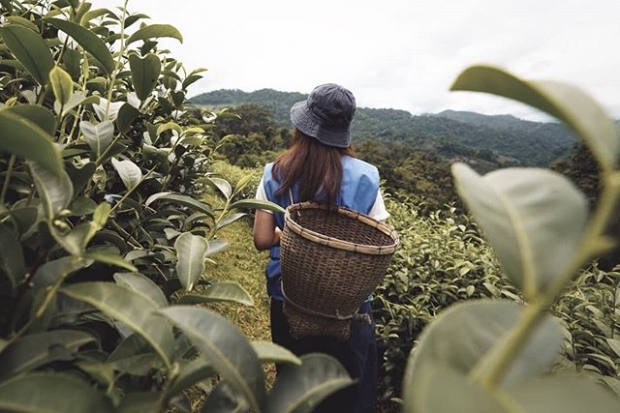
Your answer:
[291,83,355,148]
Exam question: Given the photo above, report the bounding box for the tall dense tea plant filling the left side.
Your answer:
[0,0,351,413]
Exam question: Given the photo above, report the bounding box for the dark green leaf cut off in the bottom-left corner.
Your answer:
[0,373,114,413]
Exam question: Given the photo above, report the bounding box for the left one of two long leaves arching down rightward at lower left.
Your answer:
[60,282,174,369]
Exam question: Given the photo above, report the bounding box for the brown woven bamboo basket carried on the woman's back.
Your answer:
[280,202,399,340]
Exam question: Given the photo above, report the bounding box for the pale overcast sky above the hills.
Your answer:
[94,0,620,119]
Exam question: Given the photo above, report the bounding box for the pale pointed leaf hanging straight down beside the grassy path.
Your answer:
[174,232,209,291]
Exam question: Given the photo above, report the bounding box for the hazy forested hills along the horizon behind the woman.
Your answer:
[190,89,577,167]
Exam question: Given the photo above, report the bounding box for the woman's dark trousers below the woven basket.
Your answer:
[271,299,377,413]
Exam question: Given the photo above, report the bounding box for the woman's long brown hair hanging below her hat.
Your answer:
[272,129,354,205]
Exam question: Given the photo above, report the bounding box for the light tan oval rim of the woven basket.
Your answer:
[284,202,400,255]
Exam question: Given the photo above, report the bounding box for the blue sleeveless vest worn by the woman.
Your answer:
[263,156,379,301]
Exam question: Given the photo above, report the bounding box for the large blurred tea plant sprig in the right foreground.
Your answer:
[403,66,620,412]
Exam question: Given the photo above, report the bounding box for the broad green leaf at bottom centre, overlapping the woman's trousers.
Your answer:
[264,353,355,413]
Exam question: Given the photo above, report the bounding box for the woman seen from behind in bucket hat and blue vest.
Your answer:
[254,83,389,413]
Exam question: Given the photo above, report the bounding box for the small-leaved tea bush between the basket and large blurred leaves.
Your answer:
[373,197,520,401]
